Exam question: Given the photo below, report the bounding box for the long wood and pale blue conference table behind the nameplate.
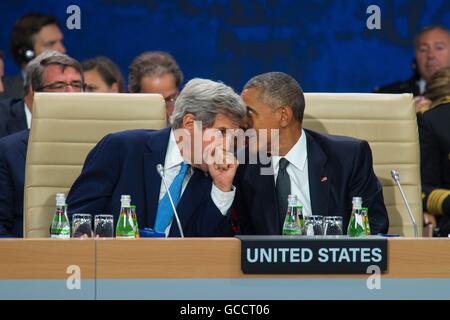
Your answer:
[0,238,450,300]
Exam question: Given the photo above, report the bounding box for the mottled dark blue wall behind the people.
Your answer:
[0,0,450,92]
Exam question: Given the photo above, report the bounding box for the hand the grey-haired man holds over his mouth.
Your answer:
[208,151,239,192]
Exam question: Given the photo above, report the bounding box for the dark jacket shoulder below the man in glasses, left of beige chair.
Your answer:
[0,99,27,138]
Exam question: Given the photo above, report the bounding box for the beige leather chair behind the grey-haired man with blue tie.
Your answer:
[24,93,166,238]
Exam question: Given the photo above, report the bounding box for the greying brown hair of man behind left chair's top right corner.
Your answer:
[128,51,183,93]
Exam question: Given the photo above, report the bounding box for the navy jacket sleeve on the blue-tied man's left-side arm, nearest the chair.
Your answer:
[67,135,120,219]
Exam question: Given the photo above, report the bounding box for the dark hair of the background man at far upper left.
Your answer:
[10,13,59,65]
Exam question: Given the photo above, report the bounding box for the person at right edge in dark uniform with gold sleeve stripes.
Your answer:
[417,68,450,237]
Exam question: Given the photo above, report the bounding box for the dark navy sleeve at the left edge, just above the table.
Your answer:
[0,144,16,236]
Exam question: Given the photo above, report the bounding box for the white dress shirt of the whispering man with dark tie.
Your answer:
[272,129,312,216]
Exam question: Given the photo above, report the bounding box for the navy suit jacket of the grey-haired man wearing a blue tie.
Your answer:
[67,128,231,237]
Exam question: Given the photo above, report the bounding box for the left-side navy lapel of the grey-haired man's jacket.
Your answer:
[143,128,170,227]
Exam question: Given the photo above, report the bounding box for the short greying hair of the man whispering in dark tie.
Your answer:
[244,72,305,123]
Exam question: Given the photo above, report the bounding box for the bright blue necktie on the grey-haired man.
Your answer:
[154,162,189,233]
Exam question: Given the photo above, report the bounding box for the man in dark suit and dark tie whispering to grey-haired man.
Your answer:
[233,72,389,235]
